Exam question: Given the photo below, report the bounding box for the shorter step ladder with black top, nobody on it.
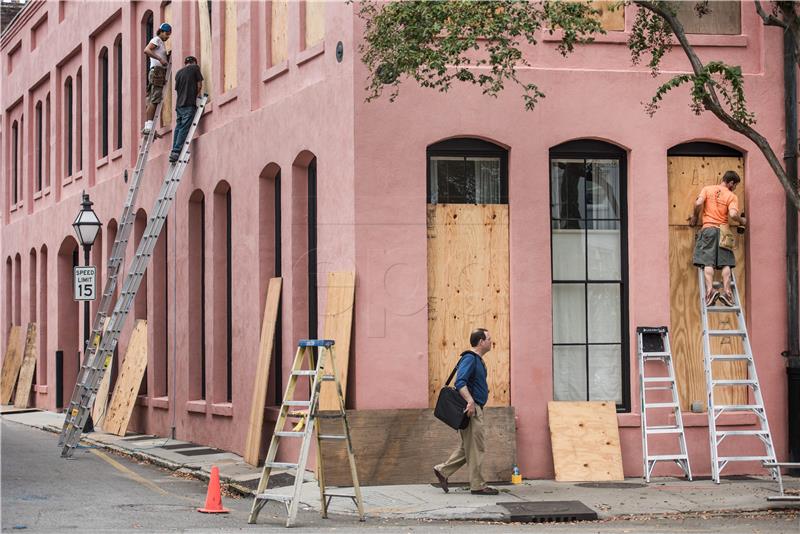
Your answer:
[636,326,692,482]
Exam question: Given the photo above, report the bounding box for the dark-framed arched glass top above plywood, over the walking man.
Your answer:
[428,138,508,204]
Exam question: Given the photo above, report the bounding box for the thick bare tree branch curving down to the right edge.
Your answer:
[634,0,800,210]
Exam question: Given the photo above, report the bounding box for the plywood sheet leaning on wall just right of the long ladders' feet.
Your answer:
[103,319,147,436]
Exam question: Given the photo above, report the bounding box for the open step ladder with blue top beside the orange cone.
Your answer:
[247,339,364,527]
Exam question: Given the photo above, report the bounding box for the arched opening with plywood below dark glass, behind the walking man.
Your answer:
[427,139,510,406]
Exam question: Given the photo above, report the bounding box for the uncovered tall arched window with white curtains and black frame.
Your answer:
[550,140,630,410]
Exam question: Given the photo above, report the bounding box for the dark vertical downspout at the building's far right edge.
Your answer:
[783,23,800,472]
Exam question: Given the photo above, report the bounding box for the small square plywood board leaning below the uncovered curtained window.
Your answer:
[547,401,625,482]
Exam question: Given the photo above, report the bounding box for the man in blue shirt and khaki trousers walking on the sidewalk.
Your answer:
[433,328,498,495]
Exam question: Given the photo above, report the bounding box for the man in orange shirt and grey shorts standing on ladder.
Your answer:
[689,171,747,306]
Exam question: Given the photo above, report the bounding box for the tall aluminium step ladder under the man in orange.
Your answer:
[697,269,783,494]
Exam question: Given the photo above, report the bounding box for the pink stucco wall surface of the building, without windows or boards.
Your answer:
[0,1,787,477]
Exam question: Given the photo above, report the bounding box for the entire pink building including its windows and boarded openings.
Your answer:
[0,0,787,477]
